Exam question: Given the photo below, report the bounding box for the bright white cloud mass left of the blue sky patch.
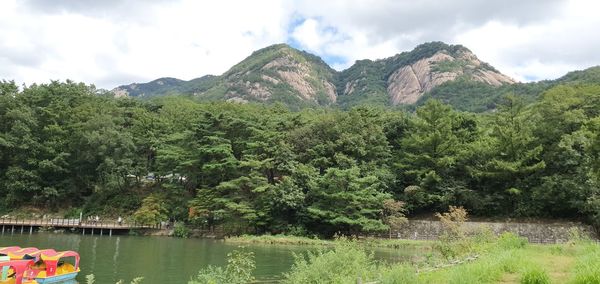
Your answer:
[0,0,289,88]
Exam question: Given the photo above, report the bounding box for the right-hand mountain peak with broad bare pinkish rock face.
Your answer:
[338,42,515,108]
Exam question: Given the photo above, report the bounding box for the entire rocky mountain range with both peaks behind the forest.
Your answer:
[113,42,556,111]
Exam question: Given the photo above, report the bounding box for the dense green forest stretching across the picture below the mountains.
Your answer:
[0,81,600,235]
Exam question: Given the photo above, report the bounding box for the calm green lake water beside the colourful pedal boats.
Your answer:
[0,233,417,284]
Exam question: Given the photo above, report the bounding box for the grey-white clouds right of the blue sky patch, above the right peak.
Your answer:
[288,0,600,81]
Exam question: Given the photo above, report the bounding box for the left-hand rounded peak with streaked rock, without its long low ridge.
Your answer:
[198,44,337,105]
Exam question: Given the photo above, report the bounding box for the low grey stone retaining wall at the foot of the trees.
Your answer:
[392,220,598,243]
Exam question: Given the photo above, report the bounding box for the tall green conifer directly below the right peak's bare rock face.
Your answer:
[394,100,475,210]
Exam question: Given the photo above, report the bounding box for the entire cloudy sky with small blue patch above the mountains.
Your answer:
[0,0,600,89]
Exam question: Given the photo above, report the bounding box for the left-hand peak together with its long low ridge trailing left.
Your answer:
[113,44,337,107]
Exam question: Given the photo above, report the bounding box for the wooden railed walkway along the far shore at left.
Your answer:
[0,218,163,236]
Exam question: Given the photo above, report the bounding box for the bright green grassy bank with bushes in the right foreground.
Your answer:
[284,235,600,284]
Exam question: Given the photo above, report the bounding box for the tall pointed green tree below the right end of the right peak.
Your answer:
[469,96,546,215]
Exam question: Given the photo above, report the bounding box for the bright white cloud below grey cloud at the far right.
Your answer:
[453,1,600,81]
